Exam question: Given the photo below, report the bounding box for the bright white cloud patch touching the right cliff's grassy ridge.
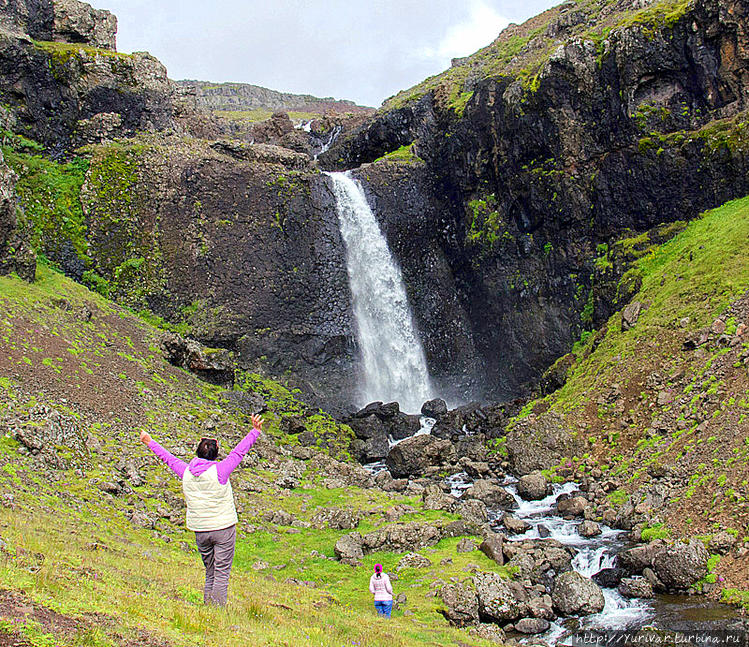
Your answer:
[420,0,510,62]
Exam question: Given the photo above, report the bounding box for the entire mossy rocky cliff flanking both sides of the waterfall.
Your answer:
[0,0,749,410]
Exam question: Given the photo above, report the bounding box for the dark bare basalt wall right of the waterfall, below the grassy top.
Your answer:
[321,0,749,404]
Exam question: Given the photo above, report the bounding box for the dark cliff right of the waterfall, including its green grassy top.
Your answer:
[322,0,749,397]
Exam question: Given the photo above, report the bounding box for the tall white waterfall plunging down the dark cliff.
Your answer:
[328,173,431,412]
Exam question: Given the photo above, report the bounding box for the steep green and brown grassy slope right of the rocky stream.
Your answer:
[508,198,749,601]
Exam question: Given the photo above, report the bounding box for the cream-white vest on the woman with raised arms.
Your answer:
[182,465,237,532]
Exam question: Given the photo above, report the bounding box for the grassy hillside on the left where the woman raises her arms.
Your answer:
[0,265,506,647]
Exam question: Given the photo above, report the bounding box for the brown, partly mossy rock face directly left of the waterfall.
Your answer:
[82,142,356,410]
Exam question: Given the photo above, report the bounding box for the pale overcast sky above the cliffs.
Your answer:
[89,0,561,106]
